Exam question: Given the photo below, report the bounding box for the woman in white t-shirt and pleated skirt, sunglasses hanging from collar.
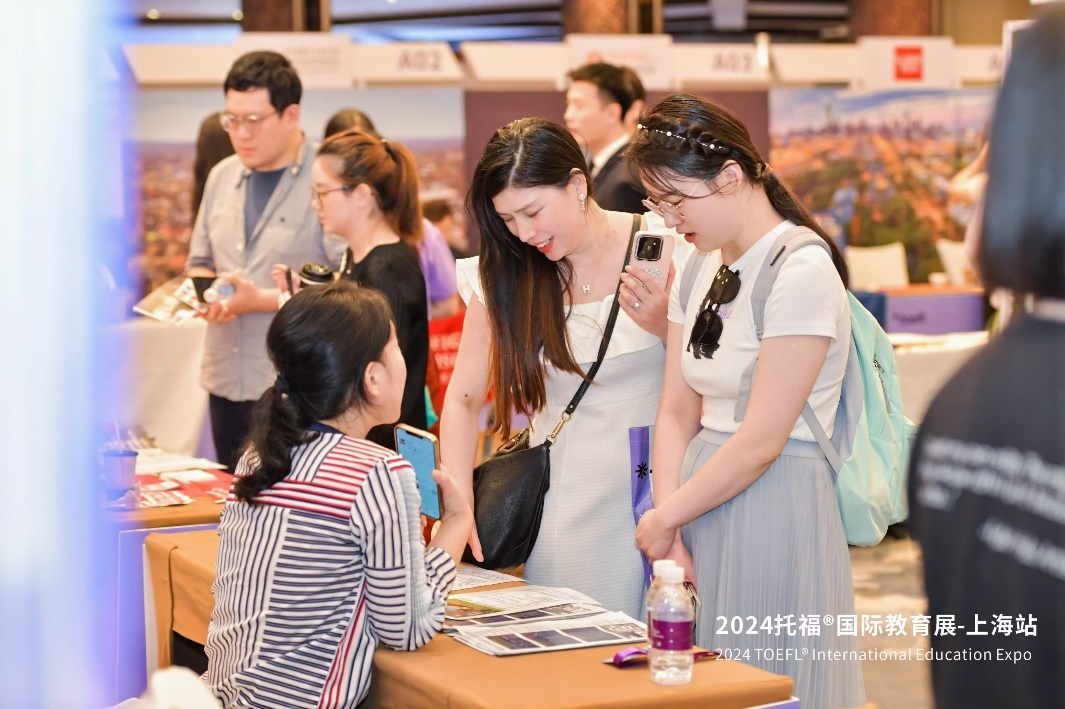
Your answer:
[628,95,865,708]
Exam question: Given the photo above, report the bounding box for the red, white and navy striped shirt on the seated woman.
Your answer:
[206,424,456,708]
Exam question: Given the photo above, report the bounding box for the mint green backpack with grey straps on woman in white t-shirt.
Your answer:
[679,227,917,546]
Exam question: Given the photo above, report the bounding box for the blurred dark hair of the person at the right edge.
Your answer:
[977,5,1065,299]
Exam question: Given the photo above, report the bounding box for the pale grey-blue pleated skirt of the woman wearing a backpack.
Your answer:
[681,430,866,709]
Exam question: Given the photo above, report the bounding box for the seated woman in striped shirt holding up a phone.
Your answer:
[206,281,473,708]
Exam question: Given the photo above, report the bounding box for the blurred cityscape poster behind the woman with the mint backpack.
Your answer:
[769,88,995,282]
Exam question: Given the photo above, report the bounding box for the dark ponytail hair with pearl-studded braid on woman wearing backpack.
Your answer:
[625,94,850,286]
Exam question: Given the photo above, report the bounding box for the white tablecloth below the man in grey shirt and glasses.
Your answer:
[105,317,214,458]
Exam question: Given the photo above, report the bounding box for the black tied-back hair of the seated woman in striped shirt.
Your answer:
[235,280,392,501]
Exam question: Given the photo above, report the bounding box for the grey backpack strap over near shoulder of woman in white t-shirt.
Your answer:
[735,226,843,475]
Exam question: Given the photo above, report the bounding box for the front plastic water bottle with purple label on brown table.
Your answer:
[648,566,695,685]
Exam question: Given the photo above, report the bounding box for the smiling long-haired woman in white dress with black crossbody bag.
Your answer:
[440,118,690,617]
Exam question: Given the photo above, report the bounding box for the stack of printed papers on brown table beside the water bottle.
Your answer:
[444,586,646,656]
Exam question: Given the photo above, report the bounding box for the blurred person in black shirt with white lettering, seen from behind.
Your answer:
[910,6,1065,709]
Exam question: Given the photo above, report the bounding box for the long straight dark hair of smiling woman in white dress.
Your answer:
[466,118,591,431]
